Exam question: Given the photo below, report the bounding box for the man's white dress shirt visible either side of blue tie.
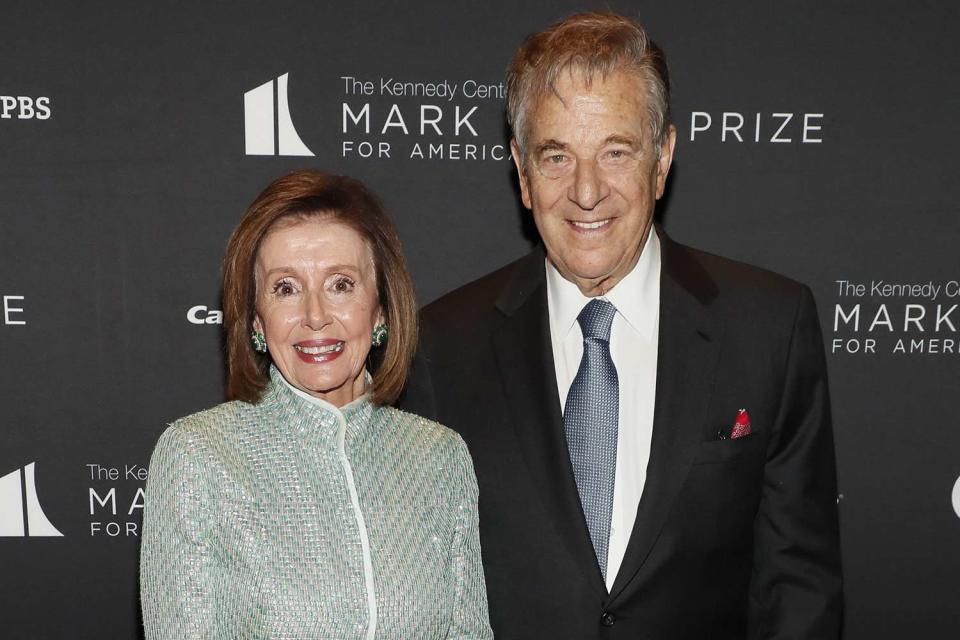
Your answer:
[546,228,660,591]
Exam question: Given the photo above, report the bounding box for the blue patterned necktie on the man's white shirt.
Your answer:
[563,298,620,579]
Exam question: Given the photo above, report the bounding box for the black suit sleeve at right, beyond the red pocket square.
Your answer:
[748,287,843,640]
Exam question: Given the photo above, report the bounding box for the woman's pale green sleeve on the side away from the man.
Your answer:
[140,425,213,640]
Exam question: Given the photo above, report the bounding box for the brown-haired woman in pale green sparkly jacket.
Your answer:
[141,171,492,640]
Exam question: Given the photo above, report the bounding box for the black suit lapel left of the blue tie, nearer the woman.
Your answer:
[493,250,606,596]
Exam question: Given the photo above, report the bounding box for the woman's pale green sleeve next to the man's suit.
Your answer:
[447,436,493,640]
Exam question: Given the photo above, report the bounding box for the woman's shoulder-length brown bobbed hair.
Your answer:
[223,170,417,404]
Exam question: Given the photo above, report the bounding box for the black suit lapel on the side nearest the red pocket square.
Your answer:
[609,228,721,603]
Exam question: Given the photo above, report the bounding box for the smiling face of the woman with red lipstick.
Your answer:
[253,218,381,407]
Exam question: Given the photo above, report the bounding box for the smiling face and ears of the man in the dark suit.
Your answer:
[511,71,676,296]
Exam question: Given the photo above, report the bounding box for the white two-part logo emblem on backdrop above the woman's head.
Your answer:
[243,73,313,156]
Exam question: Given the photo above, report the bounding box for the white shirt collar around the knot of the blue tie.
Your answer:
[545,227,660,340]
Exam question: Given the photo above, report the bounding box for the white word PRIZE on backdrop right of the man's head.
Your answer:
[690,111,823,144]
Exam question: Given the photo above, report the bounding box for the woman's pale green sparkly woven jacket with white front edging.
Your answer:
[140,370,493,640]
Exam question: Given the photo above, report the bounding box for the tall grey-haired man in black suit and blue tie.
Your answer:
[406,14,841,640]
